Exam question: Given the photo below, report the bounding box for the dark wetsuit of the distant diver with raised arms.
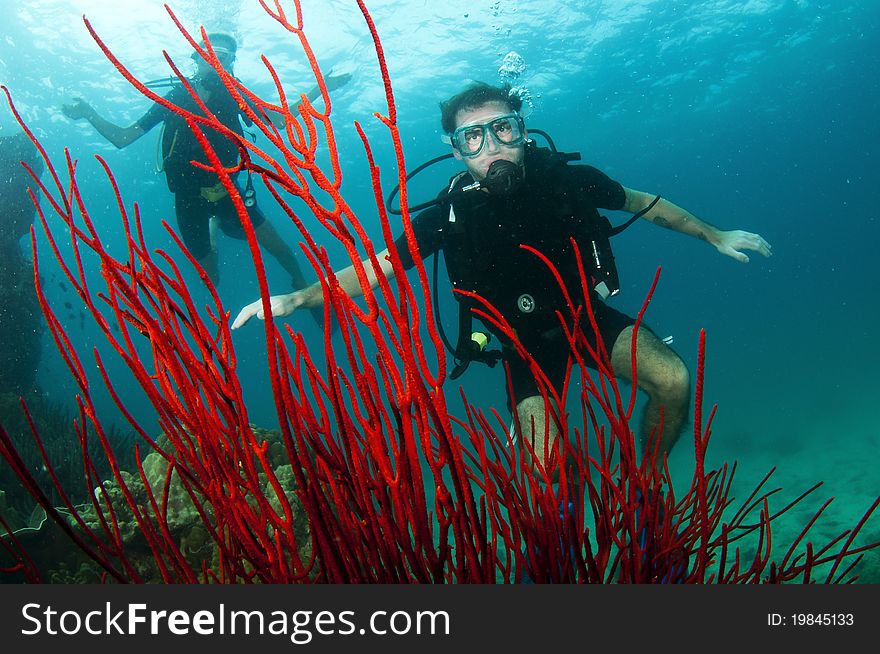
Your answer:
[137,81,266,259]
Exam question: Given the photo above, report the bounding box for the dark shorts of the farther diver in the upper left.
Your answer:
[174,182,266,259]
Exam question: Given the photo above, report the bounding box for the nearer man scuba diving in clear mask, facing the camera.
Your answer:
[232,82,771,466]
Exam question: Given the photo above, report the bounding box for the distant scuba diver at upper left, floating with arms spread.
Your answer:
[62,32,351,289]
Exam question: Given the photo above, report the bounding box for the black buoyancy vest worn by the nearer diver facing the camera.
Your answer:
[434,145,616,355]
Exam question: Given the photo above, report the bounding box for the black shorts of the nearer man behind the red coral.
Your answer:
[505,300,648,409]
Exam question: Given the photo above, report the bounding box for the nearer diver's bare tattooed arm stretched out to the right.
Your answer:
[623,188,772,263]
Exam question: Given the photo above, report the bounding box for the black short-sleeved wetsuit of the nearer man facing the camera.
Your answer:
[395,147,635,402]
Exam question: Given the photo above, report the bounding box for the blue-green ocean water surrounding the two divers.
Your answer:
[0,0,880,576]
